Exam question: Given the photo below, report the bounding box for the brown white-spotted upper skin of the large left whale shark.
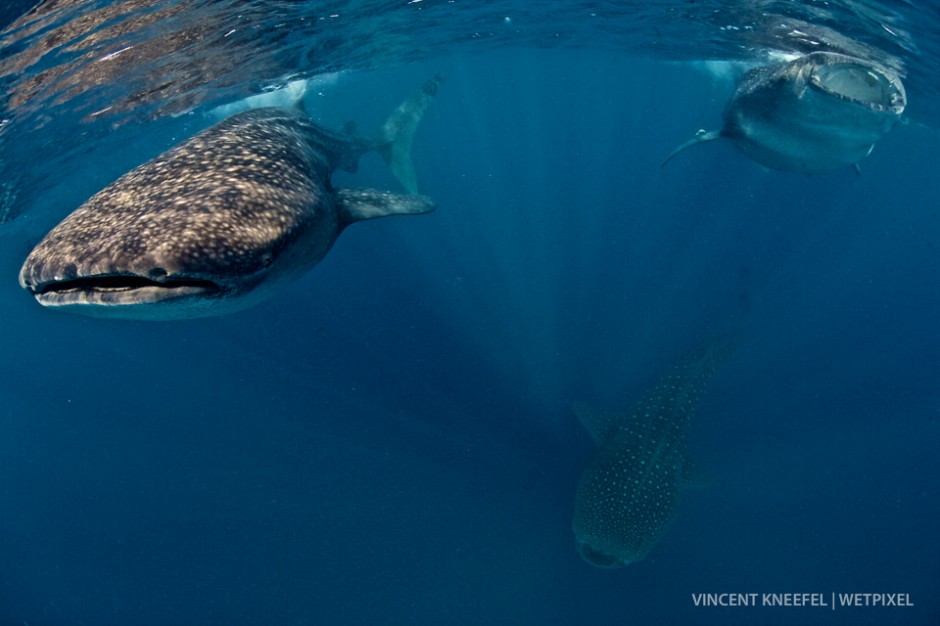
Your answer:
[23,109,336,285]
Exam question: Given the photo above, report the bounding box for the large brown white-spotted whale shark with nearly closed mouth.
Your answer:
[19,76,443,320]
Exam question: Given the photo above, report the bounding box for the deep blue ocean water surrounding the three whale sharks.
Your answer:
[0,2,940,626]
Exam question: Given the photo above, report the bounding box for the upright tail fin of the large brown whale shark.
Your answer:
[378,74,444,194]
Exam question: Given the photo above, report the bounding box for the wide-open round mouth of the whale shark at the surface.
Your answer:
[810,63,904,112]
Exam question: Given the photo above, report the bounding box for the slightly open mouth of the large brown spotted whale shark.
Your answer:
[29,274,223,306]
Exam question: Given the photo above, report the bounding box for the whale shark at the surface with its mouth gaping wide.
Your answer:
[663,52,907,174]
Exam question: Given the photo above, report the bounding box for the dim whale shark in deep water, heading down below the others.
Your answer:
[573,342,731,568]
